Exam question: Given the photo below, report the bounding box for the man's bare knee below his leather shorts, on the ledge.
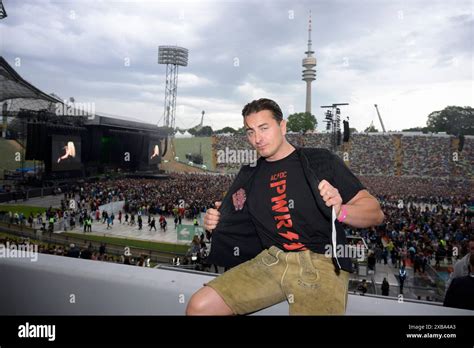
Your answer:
[186,286,233,315]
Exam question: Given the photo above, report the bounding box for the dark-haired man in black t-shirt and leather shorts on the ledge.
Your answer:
[186,99,384,315]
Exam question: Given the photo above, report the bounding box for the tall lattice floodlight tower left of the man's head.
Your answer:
[158,46,188,129]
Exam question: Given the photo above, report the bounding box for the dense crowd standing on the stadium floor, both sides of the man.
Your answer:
[2,174,474,272]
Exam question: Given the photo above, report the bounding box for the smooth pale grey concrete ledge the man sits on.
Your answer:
[0,254,474,315]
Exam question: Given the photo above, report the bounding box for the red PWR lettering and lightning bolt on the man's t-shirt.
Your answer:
[270,171,306,250]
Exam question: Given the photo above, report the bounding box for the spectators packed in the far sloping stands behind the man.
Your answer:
[213,133,474,178]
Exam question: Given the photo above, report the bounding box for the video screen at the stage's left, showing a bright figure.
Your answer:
[51,135,81,171]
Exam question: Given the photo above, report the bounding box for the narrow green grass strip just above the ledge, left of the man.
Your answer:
[62,232,189,254]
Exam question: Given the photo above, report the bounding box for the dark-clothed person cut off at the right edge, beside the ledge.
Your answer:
[444,252,474,311]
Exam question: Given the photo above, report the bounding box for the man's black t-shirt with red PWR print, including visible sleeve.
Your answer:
[248,151,364,254]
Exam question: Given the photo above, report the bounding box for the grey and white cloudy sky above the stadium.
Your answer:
[0,0,474,131]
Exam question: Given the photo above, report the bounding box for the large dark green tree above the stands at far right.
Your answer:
[426,106,474,135]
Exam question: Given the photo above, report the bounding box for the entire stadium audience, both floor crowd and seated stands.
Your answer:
[4,134,474,286]
